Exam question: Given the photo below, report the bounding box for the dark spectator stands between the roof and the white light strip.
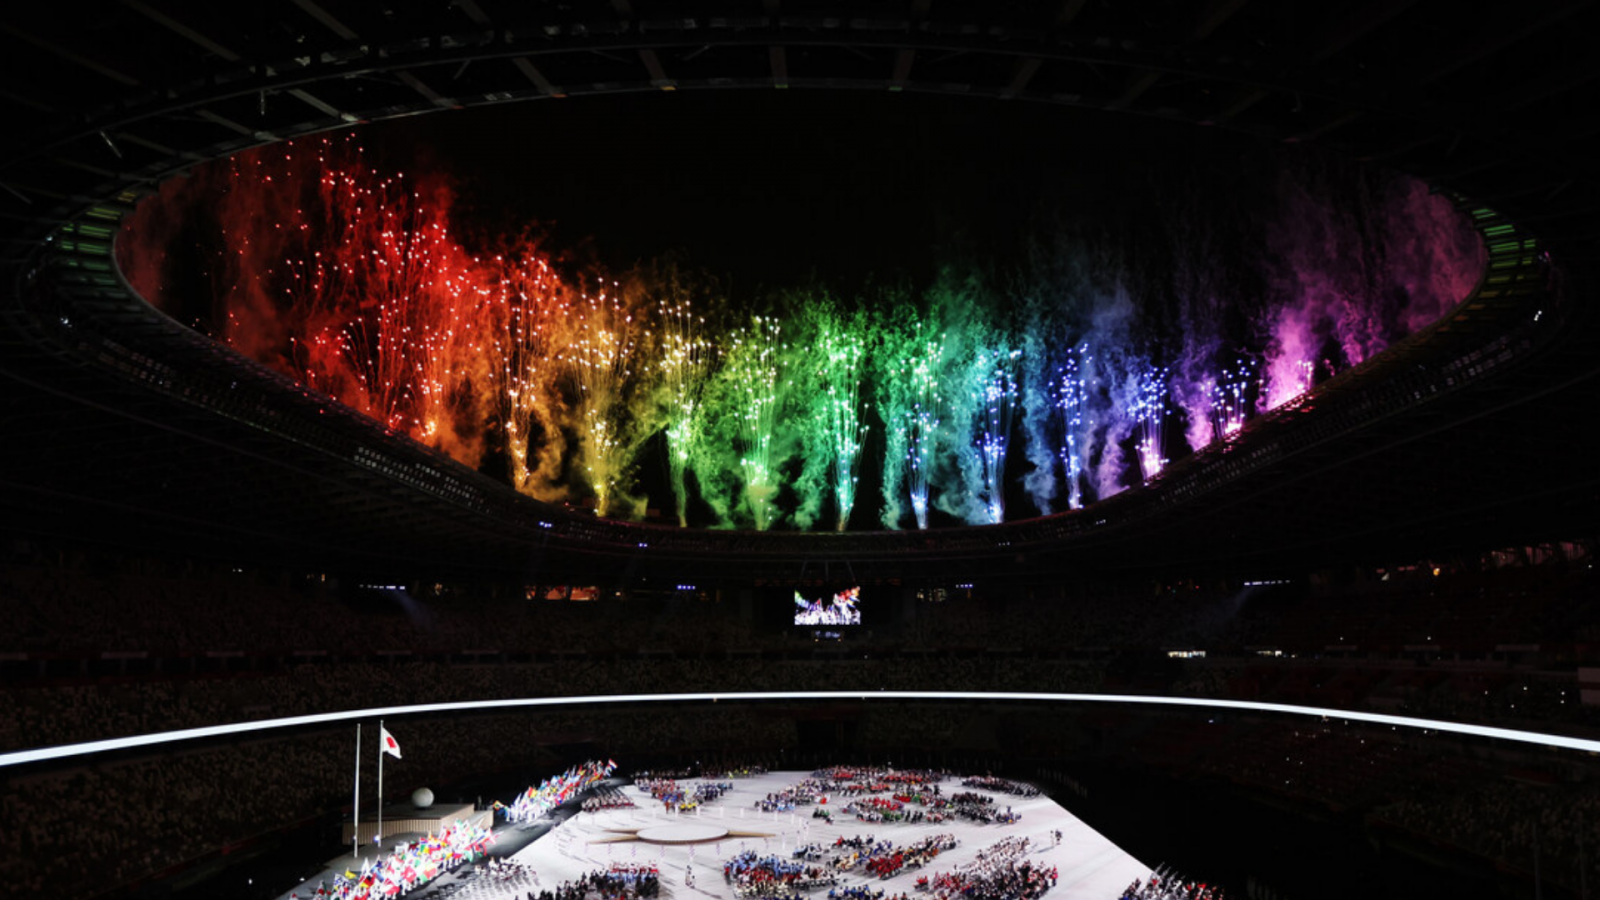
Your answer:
[0,562,1600,749]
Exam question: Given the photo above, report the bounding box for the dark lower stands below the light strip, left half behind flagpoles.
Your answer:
[0,709,794,898]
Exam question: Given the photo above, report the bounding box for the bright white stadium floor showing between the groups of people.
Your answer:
[281,772,1150,900]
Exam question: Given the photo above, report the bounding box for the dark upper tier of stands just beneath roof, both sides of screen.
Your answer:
[0,552,1595,658]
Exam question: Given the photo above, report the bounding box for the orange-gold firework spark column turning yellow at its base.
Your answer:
[562,283,648,516]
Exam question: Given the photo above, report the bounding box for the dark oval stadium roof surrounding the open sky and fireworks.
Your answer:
[0,0,1600,578]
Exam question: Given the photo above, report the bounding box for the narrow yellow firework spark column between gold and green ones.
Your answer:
[656,286,717,525]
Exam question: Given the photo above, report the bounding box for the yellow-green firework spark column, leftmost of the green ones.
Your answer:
[723,315,787,532]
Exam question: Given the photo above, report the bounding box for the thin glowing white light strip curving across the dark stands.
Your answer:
[0,690,1600,769]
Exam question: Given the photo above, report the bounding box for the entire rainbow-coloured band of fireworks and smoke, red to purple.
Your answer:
[118,139,1482,530]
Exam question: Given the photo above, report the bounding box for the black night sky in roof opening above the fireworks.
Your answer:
[362,90,1261,288]
